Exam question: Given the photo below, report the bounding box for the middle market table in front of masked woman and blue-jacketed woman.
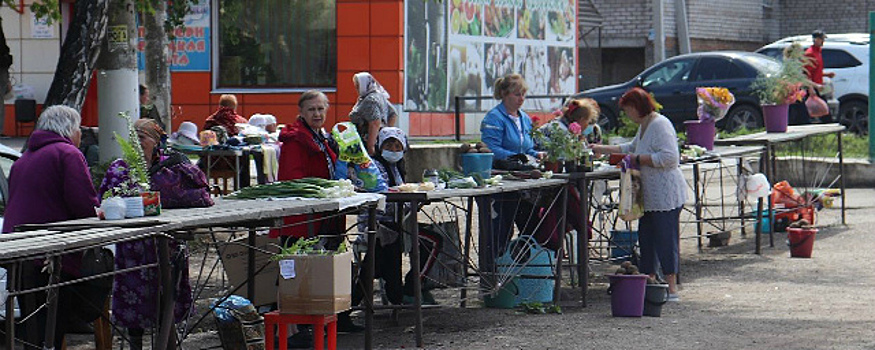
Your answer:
[382,179,567,347]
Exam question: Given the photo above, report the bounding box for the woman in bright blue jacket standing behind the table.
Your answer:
[477,74,544,287]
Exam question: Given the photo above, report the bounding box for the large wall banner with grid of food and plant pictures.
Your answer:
[404,0,577,112]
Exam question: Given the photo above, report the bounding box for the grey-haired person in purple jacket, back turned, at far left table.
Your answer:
[3,106,103,348]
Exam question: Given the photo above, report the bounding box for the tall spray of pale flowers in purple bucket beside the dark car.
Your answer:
[751,43,811,132]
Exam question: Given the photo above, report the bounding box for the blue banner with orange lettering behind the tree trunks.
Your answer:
[137,0,210,72]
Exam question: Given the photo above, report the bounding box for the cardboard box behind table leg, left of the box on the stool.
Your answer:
[219,235,279,306]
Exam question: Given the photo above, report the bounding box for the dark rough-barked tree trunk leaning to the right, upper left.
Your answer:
[45,0,109,111]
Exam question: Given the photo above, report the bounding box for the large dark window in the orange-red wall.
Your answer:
[214,0,337,89]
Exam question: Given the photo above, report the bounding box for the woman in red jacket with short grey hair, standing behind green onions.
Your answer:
[271,90,338,239]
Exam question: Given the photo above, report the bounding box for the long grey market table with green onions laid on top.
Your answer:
[6,193,383,349]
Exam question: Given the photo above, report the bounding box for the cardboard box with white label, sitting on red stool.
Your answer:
[277,252,352,315]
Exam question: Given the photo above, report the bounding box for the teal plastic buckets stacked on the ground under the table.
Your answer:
[484,236,556,309]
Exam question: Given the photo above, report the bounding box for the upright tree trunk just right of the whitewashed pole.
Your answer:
[143,1,173,133]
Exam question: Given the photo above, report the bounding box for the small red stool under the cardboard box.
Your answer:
[264,311,337,350]
